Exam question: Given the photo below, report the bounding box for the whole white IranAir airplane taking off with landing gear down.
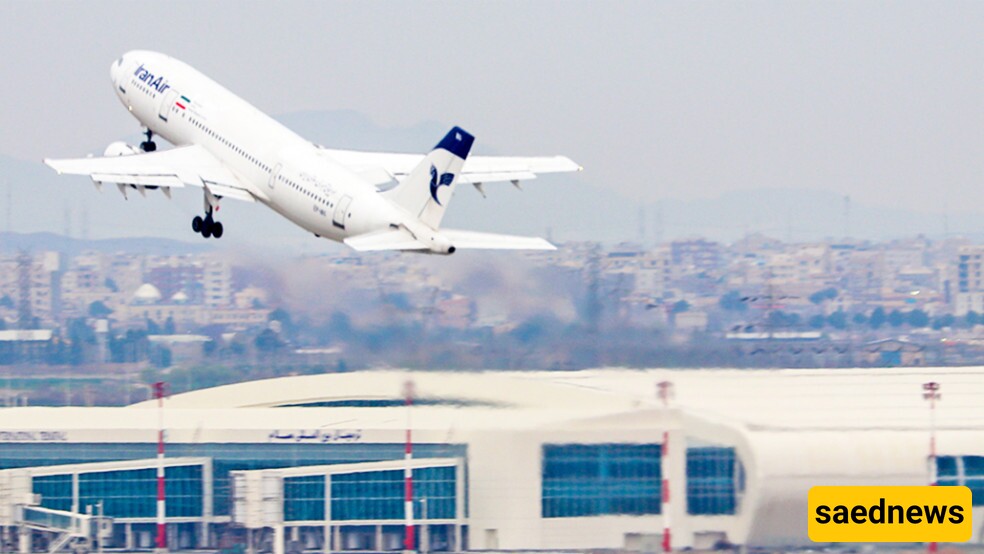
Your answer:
[44,51,581,254]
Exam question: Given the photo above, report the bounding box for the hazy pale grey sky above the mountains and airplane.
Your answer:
[0,0,984,212]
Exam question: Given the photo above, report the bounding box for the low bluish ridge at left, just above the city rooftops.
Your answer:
[0,233,214,255]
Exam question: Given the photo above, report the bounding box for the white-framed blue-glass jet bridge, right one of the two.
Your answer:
[232,458,467,554]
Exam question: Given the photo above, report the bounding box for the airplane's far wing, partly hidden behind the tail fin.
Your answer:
[321,148,582,189]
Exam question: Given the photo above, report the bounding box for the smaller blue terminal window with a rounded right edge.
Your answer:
[687,447,744,515]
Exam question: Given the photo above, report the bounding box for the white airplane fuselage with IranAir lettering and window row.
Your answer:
[111,51,408,241]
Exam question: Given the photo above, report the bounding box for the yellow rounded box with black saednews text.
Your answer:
[808,487,973,542]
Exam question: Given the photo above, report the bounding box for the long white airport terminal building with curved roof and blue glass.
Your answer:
[0,368,984,552]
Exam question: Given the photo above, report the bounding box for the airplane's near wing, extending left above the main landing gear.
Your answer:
[44,145,256,202]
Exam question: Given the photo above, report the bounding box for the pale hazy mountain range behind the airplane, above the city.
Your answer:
[0,111,984,248]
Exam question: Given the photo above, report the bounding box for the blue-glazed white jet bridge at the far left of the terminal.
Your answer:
[0,457,216,553]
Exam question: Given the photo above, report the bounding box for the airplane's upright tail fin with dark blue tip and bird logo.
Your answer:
[383,127,475,229]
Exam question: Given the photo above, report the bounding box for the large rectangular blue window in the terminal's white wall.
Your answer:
[541,444,662,518]
